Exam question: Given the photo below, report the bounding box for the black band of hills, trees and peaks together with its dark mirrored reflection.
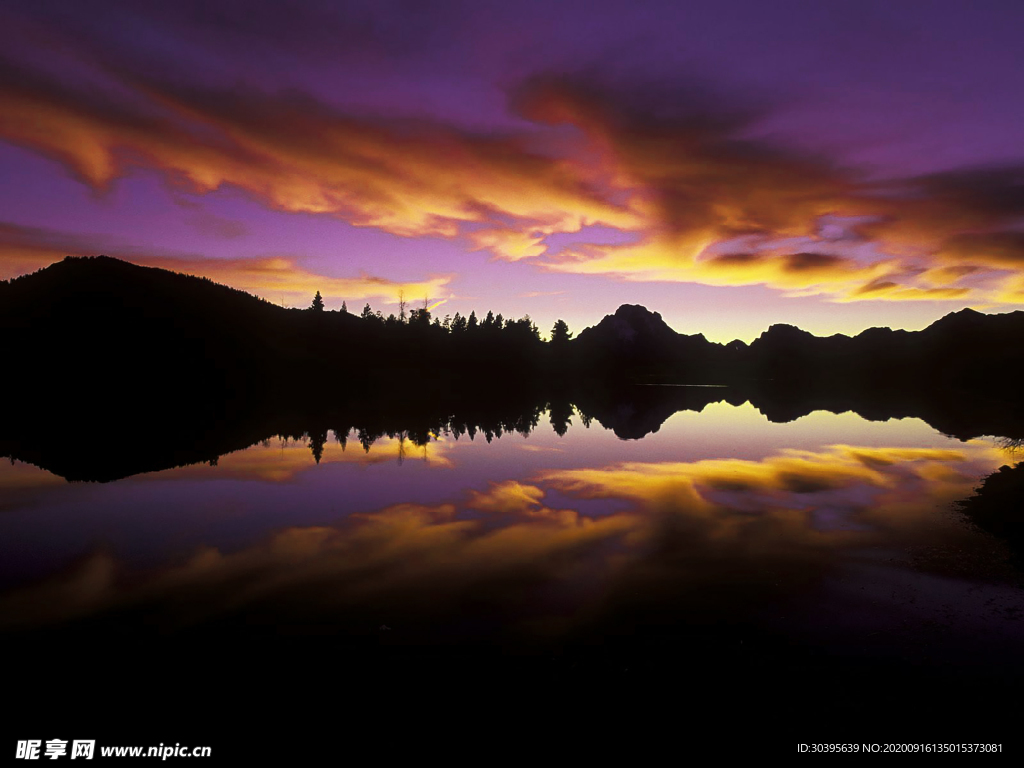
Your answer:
[0,257,1024,480]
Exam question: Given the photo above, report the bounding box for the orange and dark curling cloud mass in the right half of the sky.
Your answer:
[520,78,1024,301]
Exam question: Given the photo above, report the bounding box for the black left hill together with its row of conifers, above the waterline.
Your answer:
[0,257,557,399]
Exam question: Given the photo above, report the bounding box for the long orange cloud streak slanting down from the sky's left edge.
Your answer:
[0,59,638,237]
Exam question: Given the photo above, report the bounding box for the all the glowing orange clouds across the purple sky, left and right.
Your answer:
[0,58,1024,302]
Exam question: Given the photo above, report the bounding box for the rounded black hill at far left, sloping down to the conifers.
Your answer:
[0,256,358,390]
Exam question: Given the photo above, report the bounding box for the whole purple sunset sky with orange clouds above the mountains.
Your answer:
[0,0,1024,341]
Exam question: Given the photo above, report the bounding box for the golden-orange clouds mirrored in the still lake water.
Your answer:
[0,440,1001,642]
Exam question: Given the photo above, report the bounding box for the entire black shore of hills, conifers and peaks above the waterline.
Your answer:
[0,256,1024,397]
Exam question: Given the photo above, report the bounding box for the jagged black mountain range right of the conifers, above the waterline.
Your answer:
[572,304,1024,386]
